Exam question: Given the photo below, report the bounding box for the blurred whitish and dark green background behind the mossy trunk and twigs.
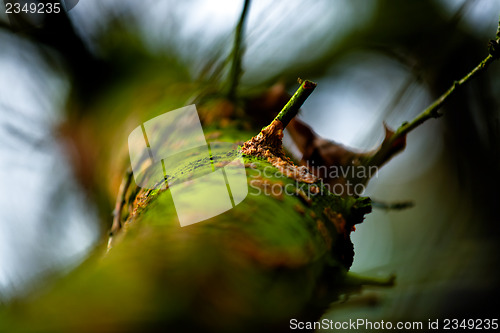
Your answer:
[0,0,500,328]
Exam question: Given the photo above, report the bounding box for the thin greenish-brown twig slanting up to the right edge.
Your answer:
[365,21,500,166]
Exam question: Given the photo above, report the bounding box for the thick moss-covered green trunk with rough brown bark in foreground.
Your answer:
[0,80,390,332]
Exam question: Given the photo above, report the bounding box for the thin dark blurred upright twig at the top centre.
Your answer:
[227,0,251,100]
